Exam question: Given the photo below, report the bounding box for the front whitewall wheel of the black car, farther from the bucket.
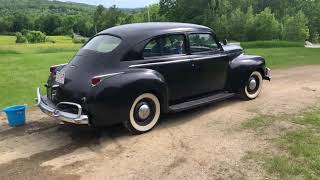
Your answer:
[240,71,263,100]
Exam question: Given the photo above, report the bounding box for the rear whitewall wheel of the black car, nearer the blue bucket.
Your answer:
[124,93,161,134]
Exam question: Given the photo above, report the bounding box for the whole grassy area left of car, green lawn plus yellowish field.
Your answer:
[0,36,81,108]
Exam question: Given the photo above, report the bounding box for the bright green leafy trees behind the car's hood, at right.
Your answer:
[160,0,320,41]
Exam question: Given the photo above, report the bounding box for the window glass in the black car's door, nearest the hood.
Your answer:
[189,34,218,53]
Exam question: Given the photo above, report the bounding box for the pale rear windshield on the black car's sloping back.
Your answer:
[82,35,121,53]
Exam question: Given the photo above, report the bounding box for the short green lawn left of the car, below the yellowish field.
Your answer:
[0,52,74,108]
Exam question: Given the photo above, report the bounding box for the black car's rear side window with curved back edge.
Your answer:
[143,35,186,57]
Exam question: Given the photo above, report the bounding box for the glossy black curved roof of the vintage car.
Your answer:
[97,22,212,43]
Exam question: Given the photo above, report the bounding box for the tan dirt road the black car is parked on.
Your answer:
[0,66,320,180]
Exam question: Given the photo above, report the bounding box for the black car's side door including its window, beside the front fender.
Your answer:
[188,33,229,94]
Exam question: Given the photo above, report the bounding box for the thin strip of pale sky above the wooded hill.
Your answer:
[61,0,159,8]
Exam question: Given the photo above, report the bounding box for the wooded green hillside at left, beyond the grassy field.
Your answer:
[0,0,149,37]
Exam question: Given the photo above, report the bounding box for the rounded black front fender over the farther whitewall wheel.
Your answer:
[227,54,268,92]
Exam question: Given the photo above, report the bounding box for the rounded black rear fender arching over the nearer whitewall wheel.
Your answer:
[88,69,168,125]
